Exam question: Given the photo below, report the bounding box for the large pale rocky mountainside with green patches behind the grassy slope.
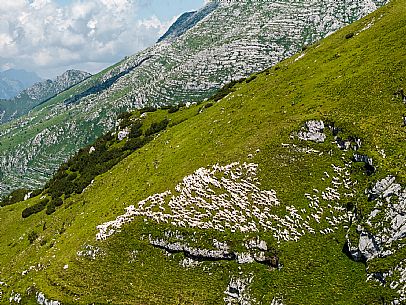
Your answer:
[0,0,386,194]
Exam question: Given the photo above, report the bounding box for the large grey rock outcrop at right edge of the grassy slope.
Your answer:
[347,176,406,304]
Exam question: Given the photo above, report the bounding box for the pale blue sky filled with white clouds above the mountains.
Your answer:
[0,0,206,78]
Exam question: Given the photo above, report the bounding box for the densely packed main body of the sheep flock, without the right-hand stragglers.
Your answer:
[96,163,279,240]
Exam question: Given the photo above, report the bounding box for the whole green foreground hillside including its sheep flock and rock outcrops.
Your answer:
[0,0,406,305]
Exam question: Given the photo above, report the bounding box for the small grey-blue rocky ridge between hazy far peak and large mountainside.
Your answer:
[0,70,91,123]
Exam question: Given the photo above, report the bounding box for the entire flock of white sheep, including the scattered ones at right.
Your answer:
[96,159,353,245]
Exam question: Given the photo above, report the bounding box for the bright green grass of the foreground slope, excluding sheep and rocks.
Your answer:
[0,0,406,304]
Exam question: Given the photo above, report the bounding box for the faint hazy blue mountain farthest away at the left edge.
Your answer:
[0,69,41,99]
